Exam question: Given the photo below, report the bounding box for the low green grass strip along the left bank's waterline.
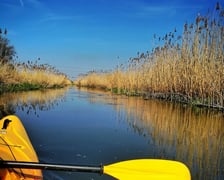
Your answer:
[0,83,69,95]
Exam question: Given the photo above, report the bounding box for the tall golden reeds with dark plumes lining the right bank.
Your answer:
[76,3,224,108]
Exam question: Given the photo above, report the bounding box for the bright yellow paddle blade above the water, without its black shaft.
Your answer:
[103,159,191,180]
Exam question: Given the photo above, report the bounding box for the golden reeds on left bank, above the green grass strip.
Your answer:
[0,58,71,88]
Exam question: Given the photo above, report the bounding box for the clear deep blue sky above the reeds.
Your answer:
[0,0,219,77]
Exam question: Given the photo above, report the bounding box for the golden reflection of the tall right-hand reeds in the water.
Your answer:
[80,89,224,179]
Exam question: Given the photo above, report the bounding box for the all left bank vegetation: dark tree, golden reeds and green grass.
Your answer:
[0,29,71,94]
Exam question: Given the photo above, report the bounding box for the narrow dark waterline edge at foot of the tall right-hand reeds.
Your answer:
[76,84,224,112]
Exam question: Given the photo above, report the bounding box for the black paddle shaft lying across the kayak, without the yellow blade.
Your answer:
[0,160,103,174]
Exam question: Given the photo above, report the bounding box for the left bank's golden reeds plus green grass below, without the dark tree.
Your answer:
[0,61,71,93]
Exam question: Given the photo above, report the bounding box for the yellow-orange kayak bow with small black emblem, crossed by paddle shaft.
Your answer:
[0,115,43,180]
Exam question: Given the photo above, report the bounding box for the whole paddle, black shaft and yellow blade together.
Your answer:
[0,159,191,180]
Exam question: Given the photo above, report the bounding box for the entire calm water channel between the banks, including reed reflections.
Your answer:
[0,87,224,180]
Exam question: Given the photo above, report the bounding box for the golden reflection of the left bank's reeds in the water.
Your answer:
[0,88,68,118]
